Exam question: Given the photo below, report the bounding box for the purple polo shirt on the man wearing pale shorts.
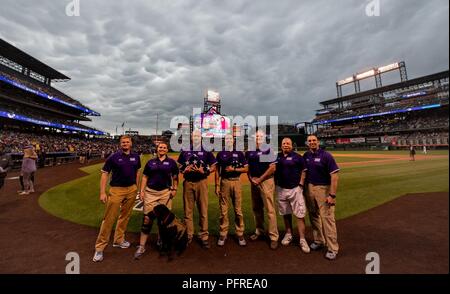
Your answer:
[275,151,306,189]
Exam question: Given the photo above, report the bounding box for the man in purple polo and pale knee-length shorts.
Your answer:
[275,138,310,253]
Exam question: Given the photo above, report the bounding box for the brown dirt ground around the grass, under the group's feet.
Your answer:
[0,164,449,274]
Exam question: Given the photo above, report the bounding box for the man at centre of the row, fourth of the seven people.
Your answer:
[215,135,248,246]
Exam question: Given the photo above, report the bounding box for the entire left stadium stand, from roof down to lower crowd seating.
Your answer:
[0,39,153,167]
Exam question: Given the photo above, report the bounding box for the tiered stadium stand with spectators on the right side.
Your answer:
[308,71,449,149]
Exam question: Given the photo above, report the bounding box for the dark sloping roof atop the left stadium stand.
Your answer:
[0,38,70,81]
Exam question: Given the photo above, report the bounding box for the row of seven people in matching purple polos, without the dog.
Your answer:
[93,131,339,262]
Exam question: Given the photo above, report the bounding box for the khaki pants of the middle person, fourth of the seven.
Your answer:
[219,178,244,237]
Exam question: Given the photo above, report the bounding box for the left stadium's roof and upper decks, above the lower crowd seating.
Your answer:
[0,39,107,135]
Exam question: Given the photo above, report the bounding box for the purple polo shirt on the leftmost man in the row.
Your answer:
[102,150,141,187]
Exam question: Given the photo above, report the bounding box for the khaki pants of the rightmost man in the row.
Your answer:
[306,184,339,253]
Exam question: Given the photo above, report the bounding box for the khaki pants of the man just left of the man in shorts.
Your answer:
[251,178,279,241]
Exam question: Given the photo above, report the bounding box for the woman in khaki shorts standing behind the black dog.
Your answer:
[134,142,178,259]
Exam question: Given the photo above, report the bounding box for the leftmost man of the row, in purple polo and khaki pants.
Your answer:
[92,136,141,262]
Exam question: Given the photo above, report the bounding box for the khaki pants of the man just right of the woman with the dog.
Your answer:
[183,179,209,240]
